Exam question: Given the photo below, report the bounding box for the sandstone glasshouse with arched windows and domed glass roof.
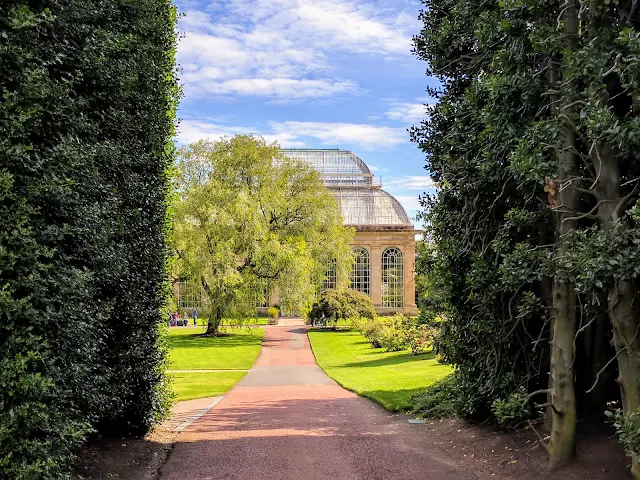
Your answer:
[282,149,417,315]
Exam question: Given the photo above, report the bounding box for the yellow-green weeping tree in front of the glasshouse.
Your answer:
[174,135,353,334]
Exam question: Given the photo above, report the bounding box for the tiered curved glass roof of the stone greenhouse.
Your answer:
[282,149,413,230]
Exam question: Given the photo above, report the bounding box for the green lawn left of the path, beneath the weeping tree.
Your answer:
[169,327,264,401]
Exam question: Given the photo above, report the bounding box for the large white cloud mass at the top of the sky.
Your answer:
[178,0,419,100]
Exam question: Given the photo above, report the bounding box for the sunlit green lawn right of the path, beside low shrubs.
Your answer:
[309,331,453,411]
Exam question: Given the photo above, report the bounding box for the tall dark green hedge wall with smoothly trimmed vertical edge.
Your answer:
[0,0,178,480]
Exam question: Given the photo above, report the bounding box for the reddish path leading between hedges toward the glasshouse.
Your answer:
[160,327,475,480]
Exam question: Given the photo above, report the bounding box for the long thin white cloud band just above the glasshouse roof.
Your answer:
[177,119,407,150]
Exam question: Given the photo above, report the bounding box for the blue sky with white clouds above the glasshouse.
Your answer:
[172,0,435,224]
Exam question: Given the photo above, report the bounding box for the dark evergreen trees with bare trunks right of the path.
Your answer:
[412,0,640,478]
